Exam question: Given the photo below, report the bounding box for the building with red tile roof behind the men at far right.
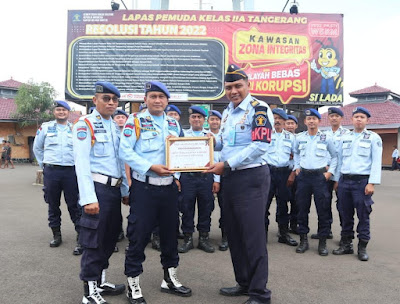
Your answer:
[320,84,400,166]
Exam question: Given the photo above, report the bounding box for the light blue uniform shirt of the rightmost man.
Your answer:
[338,129,382,184]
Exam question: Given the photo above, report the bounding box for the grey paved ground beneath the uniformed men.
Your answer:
[0,165,400,304]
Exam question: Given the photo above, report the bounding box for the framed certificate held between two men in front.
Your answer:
[166,137,214,172]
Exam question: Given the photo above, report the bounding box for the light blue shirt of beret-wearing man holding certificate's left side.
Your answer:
[119,110,181,178]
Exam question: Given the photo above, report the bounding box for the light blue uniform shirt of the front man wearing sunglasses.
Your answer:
[73,109,129,206]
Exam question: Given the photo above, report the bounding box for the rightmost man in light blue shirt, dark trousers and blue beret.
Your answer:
[333,107,382,261]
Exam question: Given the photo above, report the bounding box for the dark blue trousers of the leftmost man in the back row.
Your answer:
[43,165,81,232]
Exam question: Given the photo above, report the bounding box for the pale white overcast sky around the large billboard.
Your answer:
[0,0,400,109]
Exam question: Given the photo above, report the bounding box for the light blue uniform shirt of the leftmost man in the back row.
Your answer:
[33,120,75,168]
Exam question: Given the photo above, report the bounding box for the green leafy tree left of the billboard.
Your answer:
[13,80,57,127]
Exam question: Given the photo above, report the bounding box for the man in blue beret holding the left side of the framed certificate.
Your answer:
[119,81,192,304]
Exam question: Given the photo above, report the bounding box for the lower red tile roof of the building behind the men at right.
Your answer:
[320,100,400,127]
